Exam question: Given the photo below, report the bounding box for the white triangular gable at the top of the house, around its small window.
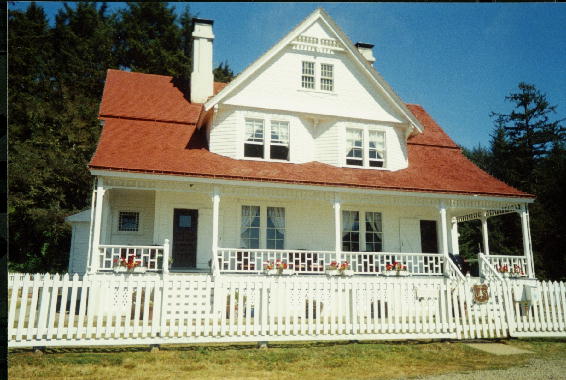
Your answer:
[205,9,423,132]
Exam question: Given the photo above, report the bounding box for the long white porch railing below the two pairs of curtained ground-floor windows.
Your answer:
[217,248,445,276]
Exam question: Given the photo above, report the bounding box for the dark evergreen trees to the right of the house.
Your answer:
[460,82,566,280]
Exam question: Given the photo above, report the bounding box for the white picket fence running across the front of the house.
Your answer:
[8,274,566,347]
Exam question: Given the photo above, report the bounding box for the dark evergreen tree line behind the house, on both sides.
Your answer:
[8,2,566,279]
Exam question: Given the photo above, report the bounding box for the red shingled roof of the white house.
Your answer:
[89,70,532,197]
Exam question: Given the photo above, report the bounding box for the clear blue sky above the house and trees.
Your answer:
[10,2,566,147]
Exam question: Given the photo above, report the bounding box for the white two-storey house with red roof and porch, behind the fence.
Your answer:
[69,9,534,277]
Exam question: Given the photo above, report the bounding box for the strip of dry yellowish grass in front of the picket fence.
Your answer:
[8,339,566,380]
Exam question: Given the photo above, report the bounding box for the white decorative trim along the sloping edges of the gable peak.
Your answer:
[204,8,424,133]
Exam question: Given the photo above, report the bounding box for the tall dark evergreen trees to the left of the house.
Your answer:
[8,2,234,272]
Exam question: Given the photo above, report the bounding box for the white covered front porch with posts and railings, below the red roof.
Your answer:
[84,172,534,278]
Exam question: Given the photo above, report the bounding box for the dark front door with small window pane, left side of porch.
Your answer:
[172,208,198,269]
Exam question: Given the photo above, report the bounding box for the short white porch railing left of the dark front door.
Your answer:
[98,244,168,272]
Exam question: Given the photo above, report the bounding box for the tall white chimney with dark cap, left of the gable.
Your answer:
[191,18,214,103]
